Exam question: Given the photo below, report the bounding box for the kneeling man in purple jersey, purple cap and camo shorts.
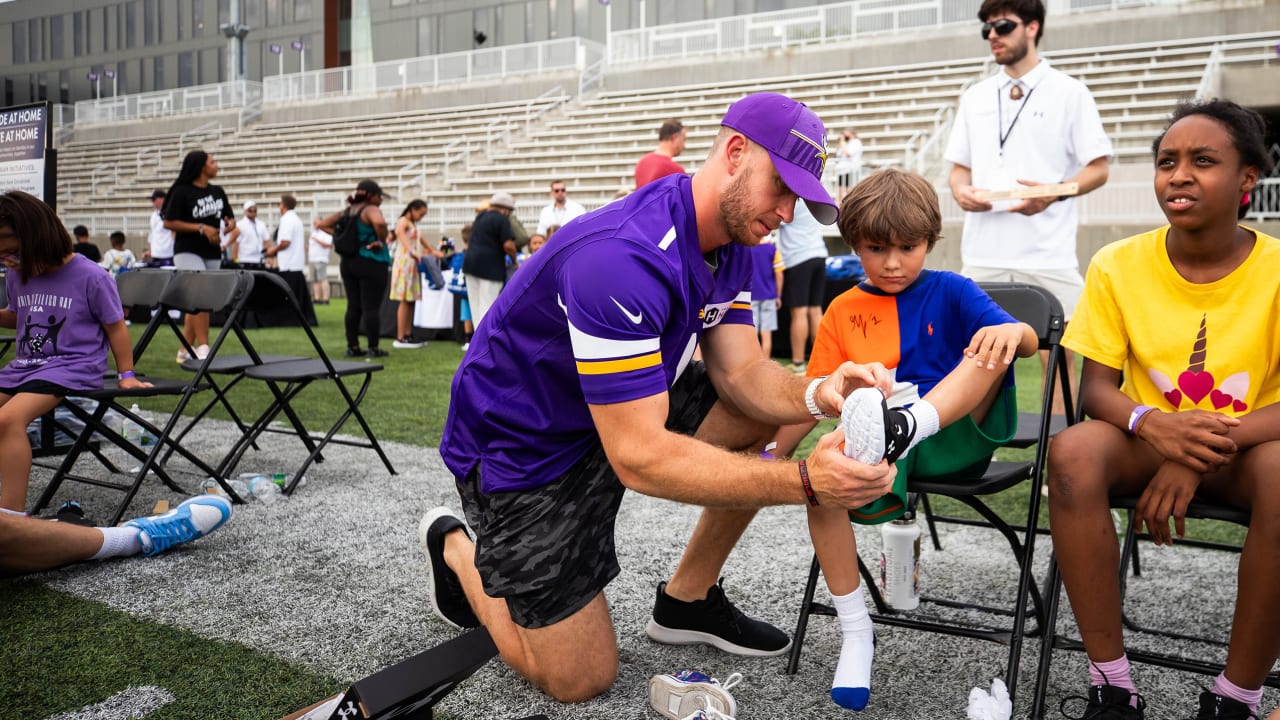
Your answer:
[419,94,893,702]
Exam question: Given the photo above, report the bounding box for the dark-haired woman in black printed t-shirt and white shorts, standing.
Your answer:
[160,150,238,363]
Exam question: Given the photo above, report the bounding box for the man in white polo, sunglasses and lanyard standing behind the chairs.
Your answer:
[946,0,1112,413]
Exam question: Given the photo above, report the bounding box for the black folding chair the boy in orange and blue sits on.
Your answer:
[787,283,1065,697]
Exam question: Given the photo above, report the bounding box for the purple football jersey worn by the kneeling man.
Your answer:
[440,176,751,492]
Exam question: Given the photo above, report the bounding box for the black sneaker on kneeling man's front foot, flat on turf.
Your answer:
[645,578,791,657]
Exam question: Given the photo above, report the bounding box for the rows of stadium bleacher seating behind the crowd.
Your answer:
[59,32,1280,237]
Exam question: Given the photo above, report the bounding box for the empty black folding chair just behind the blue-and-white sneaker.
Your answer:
[32,270,253,525]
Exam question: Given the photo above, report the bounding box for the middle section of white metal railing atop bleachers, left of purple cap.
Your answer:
[262,37,604,104]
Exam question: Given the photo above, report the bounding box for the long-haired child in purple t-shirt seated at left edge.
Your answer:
[0,191,150,514]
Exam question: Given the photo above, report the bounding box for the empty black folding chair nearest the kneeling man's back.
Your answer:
[218,270,396,495]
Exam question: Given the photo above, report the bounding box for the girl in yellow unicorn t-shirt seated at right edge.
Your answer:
[1050,100,1280,720]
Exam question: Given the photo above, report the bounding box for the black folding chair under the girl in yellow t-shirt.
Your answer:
[1030,476,1280,717]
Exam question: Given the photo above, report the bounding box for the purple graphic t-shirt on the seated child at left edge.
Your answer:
[0,255,124,389]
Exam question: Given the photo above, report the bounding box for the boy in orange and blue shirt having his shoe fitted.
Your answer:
[777,169,1039,710]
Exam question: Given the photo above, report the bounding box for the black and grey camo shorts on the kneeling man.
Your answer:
[458,363,718,629]
